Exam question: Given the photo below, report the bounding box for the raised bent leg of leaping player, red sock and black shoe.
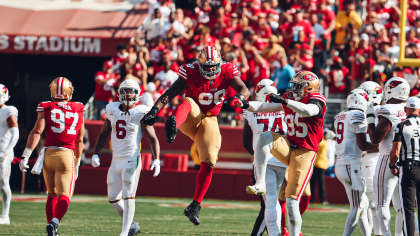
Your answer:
[165,98,196,143]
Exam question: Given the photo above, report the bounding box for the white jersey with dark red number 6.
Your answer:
[105,102,150,158]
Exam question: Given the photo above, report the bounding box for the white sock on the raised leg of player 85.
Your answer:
[255,132,273,186]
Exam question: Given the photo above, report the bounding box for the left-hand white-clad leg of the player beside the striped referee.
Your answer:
[374,156,398,236]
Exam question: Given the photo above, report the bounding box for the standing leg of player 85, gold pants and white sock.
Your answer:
[286,148,315,236]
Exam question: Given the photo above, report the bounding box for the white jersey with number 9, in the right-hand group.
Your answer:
[334,110,367,165]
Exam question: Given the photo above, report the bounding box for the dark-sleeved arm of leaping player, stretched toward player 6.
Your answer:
[141,78,188,125]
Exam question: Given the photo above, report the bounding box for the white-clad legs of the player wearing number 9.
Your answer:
[335,165,371,236]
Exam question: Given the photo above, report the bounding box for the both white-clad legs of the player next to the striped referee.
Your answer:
[373,156,403,236]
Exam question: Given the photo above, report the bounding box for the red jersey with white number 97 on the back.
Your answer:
[36,101,85,151]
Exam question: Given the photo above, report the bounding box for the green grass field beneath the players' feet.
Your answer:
[0,194,395,236]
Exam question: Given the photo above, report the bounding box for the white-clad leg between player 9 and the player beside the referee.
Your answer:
[362,152,382,235]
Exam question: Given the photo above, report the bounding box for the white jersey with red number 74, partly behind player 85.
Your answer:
[244,111,287,168]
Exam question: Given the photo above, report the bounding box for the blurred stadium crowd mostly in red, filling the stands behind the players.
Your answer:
[91,0,420,123]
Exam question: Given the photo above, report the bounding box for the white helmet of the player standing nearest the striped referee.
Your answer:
[383,77,410,103]
